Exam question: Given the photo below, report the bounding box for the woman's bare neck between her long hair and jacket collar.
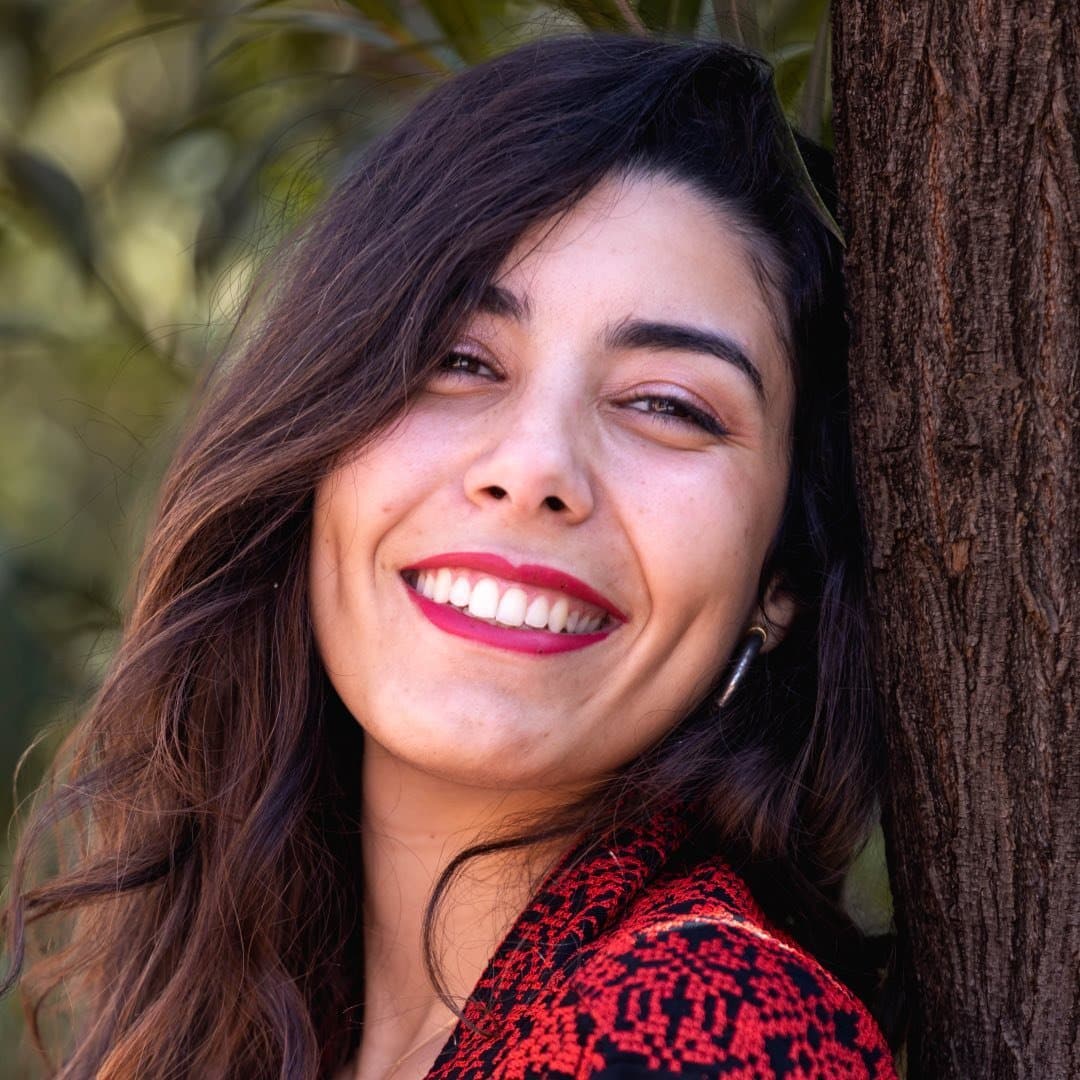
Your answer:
[356,739,569,1080]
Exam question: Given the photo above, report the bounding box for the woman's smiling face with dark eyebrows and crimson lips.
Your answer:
[310,170,793,788]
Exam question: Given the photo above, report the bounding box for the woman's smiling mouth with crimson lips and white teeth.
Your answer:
[402,552,626,656]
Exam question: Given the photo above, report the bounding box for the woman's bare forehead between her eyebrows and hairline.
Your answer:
[480,174,789,414]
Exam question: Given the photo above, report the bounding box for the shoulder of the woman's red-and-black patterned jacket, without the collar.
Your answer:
[537,860,895,1078]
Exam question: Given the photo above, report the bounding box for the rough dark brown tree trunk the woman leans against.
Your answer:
[834,0,1080,1080]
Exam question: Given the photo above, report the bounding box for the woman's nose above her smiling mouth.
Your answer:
[464,403,595,525]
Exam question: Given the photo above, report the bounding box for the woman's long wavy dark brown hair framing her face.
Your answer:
[3,36,880,1078]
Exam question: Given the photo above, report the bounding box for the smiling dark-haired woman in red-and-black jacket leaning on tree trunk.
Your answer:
[0,29,893,1080]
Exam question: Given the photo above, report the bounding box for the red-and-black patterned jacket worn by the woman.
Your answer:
[428,810,895,1080]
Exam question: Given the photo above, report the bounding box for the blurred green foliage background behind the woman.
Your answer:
[0,0,891,1080]
